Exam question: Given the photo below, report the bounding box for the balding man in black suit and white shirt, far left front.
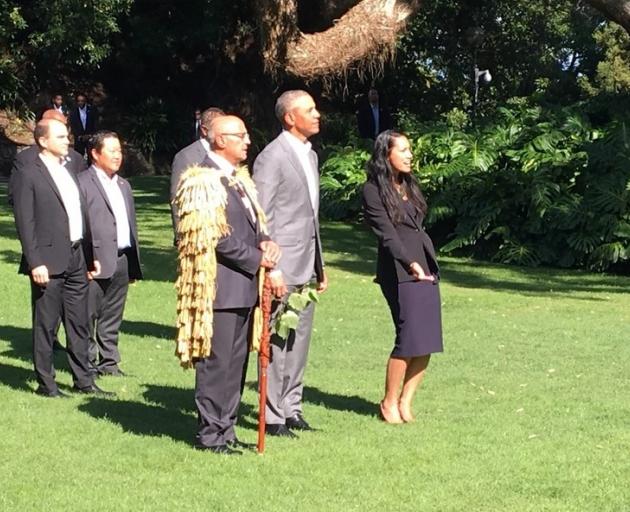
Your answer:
[11,119,109,397]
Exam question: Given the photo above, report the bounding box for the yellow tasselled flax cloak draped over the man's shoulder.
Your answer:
[175,166,230,368]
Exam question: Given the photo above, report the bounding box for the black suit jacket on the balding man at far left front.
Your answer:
[11,158,93,275]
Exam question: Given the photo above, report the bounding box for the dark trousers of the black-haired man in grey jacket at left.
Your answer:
[88,254,129,373]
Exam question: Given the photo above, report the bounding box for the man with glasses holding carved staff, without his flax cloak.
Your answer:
[184,116,280,455]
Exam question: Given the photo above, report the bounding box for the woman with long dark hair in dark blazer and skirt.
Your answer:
[363,130,442,423]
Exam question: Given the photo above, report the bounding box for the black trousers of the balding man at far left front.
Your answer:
[31,246,94,392]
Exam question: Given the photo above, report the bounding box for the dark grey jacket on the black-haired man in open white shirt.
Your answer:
[79,167,142,279]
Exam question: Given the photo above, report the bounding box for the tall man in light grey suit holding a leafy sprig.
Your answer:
[253,91,328,437]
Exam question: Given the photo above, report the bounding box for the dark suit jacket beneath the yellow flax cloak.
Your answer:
[201,158,269,309]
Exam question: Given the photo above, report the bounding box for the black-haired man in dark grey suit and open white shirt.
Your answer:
[79,131,142,376]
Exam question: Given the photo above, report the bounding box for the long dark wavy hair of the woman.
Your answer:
[366,130,427,224]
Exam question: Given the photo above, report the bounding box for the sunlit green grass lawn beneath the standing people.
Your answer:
[0,178,630,512]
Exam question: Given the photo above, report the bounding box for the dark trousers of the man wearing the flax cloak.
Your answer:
[195,308,253,446]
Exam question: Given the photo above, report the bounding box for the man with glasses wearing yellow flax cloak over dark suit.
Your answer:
[175,116,280,455]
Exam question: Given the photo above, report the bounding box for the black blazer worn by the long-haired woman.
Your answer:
[363,182,439,283]
